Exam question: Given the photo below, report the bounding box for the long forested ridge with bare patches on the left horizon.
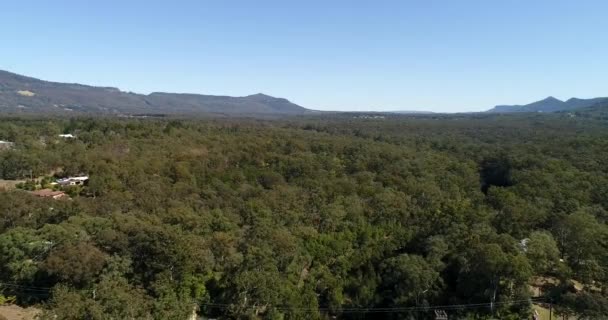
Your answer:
[0,70,309,116]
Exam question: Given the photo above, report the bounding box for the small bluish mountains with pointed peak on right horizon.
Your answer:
[487,97,608,113]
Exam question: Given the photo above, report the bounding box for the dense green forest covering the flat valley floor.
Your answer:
[0,113,608,320]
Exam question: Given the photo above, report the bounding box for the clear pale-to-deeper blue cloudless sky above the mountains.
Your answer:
[0,0,608,112]
